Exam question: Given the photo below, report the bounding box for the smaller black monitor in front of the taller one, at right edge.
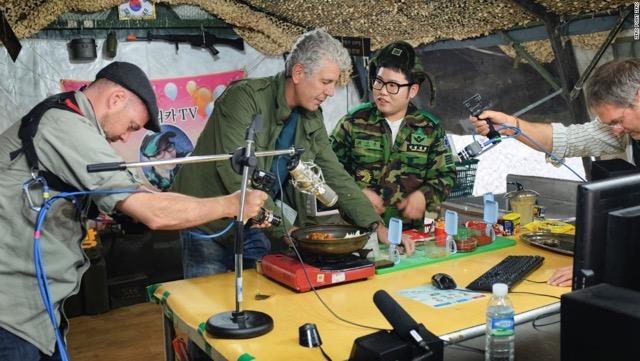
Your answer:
[602,205,640,291]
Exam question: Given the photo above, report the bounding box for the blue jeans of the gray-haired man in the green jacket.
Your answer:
[180,228,271,278]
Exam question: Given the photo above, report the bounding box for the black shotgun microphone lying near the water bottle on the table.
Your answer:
[373,290,431,352]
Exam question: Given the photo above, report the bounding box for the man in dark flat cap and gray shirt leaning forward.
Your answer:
[0,62,267,361]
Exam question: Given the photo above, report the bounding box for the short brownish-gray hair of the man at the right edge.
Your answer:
[587,58,640,108]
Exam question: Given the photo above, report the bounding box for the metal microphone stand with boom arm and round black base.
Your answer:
[87,115,301,339]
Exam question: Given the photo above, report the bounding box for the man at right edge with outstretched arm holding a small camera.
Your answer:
[470,58,640,287]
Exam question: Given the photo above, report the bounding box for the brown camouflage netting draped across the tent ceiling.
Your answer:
[0,0,633,62]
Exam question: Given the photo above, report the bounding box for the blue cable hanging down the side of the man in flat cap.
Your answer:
[33,184,139,361]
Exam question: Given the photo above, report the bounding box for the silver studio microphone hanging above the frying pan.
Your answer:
[288,159,338,207]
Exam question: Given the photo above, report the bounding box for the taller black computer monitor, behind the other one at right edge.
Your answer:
[573,174,640,290]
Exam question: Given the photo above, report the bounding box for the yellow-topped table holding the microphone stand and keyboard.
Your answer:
[149,241,572,360]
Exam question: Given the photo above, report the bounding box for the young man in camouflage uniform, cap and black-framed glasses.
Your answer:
[331,42,456,254]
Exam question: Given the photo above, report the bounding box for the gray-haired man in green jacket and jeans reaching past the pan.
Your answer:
[173,30,384,278]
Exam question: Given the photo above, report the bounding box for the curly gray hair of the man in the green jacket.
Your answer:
[284,29,351,78]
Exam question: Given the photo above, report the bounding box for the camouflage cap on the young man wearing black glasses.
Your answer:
[369,41,427,84]
